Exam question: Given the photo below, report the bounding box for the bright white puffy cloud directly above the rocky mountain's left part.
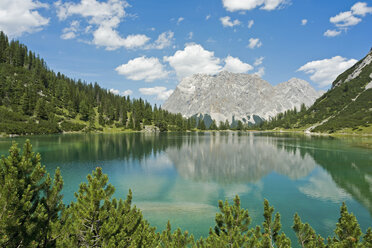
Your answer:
[164,43,221,79]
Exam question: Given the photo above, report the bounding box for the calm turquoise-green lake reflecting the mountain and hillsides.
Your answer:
[0,133,372,243]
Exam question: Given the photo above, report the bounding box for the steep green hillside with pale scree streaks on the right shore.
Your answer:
[261,49,372,133]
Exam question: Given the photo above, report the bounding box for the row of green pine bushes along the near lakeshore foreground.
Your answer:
[0,141,372,248]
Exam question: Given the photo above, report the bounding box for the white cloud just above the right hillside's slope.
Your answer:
[298,56,357,87]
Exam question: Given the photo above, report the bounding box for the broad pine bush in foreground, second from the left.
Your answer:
[58,167,157,247]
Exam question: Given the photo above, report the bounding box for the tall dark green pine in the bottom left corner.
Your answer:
[0,141,64,247]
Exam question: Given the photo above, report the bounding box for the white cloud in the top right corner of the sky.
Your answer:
[324,2,372,37]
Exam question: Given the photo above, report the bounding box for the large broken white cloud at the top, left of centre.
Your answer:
[55,0,155,50]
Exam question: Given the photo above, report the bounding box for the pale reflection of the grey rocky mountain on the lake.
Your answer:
[166,133,316,183]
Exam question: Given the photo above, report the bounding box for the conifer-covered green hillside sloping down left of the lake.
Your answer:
[0,32,201,134]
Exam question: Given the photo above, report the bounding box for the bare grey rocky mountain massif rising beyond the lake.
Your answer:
[162,71,322,124]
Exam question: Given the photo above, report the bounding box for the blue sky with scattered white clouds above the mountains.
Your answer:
[0,0,372,104]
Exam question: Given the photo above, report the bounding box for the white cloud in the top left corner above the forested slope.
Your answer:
[0,0,49,37]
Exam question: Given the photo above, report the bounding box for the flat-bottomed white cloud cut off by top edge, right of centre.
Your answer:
[222,0,288,12]
